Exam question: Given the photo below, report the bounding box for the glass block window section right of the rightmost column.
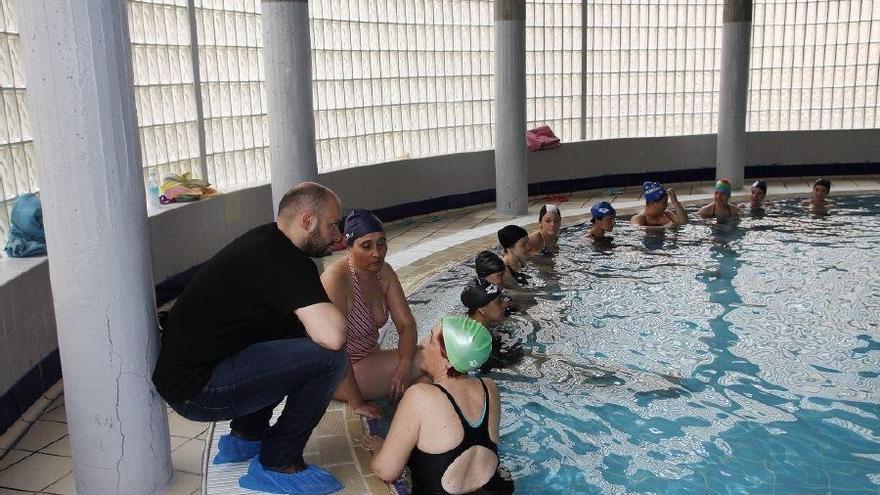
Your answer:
[746,0,880,131]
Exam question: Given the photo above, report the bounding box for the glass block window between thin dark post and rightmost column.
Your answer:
[584,0,723,140]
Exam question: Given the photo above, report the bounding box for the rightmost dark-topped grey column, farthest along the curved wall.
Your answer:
[715,0,752,190]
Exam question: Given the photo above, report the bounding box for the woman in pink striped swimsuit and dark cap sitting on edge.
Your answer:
[321,209,422,417]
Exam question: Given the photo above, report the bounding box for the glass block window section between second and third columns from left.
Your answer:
[309,0,494,172]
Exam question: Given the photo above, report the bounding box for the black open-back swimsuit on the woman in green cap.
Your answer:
[407,380,513,495]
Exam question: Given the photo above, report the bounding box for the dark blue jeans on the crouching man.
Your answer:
[170,338,348,469]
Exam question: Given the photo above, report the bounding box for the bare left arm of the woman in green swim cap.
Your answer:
[370,385,428,483]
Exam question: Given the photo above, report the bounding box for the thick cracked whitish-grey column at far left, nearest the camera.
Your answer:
[18,0,171,495]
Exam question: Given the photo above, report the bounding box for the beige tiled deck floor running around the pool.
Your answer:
[0,176,880,495]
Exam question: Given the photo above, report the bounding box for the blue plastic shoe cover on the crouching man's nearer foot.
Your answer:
[238,457,342,495]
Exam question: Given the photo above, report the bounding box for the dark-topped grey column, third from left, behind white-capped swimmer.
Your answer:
[495,0,529,215]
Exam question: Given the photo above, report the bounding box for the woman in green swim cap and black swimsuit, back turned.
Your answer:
[364,316,513,495]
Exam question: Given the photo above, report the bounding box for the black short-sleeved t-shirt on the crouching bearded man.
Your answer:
[153,223,330,402]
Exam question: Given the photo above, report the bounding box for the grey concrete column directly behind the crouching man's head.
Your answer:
[262,0,318,216]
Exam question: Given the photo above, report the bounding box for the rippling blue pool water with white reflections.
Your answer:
[396,197,880,494]
